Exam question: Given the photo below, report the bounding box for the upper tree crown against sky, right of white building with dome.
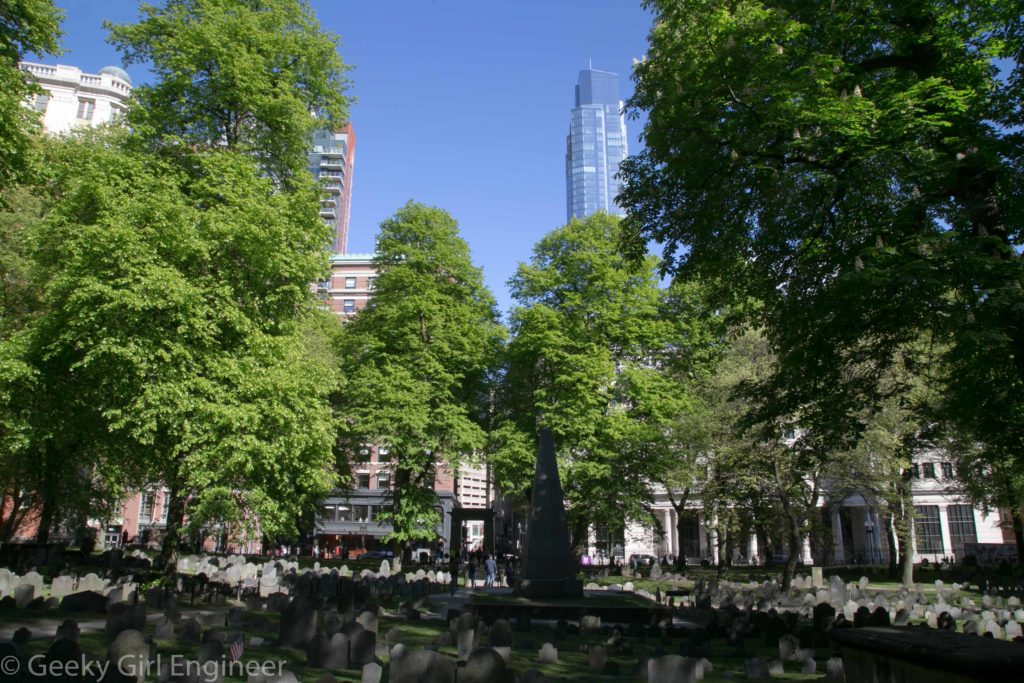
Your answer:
[105,0,348,180]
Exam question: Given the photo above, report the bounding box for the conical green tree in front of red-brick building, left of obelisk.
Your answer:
[337,202,504,544]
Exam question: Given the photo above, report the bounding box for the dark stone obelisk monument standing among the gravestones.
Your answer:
[515,429,583,598]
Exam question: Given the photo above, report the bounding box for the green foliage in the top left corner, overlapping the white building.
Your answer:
[0,0,63,188]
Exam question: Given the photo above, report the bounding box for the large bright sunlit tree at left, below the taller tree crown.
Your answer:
[23,132,335,567]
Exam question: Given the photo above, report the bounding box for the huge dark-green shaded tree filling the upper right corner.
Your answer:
[621,0,1024,509]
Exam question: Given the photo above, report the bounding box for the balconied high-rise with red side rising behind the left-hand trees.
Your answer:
[308,123,355,254]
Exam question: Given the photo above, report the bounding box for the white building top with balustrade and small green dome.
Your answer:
[19,61,132,135]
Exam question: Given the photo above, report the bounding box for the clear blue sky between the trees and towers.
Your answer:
[48,0,650,311]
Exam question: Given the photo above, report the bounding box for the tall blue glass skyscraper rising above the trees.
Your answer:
[565,69,628,220]
